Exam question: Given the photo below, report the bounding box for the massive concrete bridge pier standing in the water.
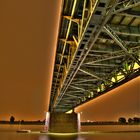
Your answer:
[46,112,80,133]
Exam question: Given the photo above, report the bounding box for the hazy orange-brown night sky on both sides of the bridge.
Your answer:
[0,0,140,120]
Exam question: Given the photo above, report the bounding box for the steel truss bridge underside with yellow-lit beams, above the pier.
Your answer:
[49,0,140,112]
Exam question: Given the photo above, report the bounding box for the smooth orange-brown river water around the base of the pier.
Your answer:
[0,124,140,140]
